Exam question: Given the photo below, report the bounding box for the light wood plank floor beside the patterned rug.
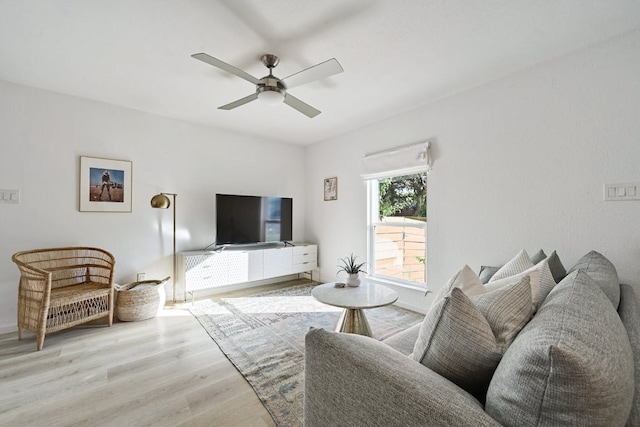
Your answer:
[0,285,300,427]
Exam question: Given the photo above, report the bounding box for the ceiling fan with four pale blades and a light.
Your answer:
[191,53,344,118]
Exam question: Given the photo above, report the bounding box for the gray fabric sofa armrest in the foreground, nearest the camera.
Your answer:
[304,328,500,427]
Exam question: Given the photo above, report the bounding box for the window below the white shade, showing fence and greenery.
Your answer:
[367,172,427,286]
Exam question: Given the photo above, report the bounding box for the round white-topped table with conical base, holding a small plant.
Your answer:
[311,280,398,337]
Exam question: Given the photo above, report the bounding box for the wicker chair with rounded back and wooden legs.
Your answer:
[11,247,115,350]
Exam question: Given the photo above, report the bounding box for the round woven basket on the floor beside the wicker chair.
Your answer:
[115,277,169,322]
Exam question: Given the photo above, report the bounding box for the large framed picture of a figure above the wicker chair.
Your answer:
[78,156,133,212]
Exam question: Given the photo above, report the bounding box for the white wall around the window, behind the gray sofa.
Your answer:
[306,31,640,308]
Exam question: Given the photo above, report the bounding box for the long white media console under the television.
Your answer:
[178,243,318,296]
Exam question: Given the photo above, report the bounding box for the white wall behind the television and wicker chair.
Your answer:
[0,82,305,332]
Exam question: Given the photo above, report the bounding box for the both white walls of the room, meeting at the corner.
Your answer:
[0,32,640,332]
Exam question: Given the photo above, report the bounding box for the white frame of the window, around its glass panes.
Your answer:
[366,176,428,290]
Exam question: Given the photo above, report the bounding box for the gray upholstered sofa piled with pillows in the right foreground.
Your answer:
[304,252,640,427]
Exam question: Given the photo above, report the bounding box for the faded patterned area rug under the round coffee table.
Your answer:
[191,284,423,427]
